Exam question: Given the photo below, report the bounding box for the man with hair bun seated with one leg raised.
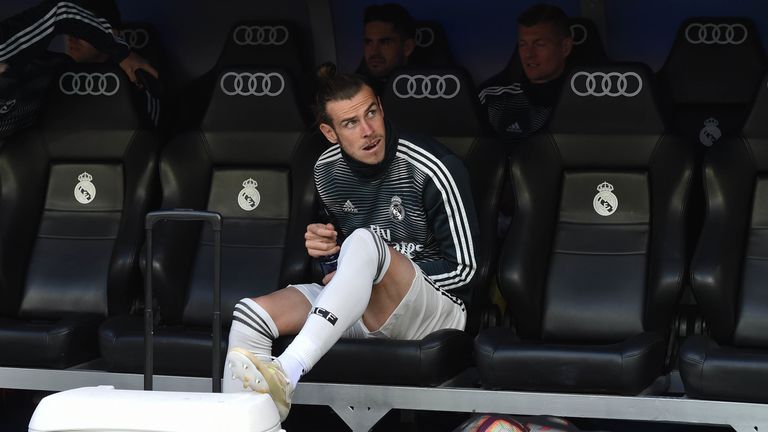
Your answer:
[223,68,478,419]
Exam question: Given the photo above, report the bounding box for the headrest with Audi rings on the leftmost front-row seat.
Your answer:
[41,63,148,130]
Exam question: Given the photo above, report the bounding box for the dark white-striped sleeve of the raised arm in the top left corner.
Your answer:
[0,0,130,68]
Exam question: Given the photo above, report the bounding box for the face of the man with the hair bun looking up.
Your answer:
[320,86,386,165]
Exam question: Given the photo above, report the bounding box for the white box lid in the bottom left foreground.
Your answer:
[29,386,282,432]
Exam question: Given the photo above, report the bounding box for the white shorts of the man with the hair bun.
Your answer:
[290,264,467,340]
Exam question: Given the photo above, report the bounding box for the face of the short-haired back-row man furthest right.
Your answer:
[517,23,572,83]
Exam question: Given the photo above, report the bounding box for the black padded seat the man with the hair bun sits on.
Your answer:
[270,67,504,386]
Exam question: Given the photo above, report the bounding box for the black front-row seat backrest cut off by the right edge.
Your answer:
[691,72,768,348]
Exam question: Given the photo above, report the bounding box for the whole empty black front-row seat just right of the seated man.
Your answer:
[475,64,693,395]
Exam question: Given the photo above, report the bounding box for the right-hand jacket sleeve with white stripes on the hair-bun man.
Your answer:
[419,154,478,289]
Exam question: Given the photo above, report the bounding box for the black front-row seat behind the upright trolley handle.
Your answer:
[100,67,326,376]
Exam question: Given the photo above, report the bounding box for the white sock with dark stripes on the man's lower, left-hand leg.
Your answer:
[222,298,279,393]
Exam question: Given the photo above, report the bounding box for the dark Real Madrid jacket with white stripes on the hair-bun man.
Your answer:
[315,123,478,296]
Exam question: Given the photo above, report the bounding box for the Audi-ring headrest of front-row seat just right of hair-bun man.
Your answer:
[549,63,664,134]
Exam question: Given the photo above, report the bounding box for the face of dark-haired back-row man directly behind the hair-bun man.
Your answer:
[363,21,413,78]
